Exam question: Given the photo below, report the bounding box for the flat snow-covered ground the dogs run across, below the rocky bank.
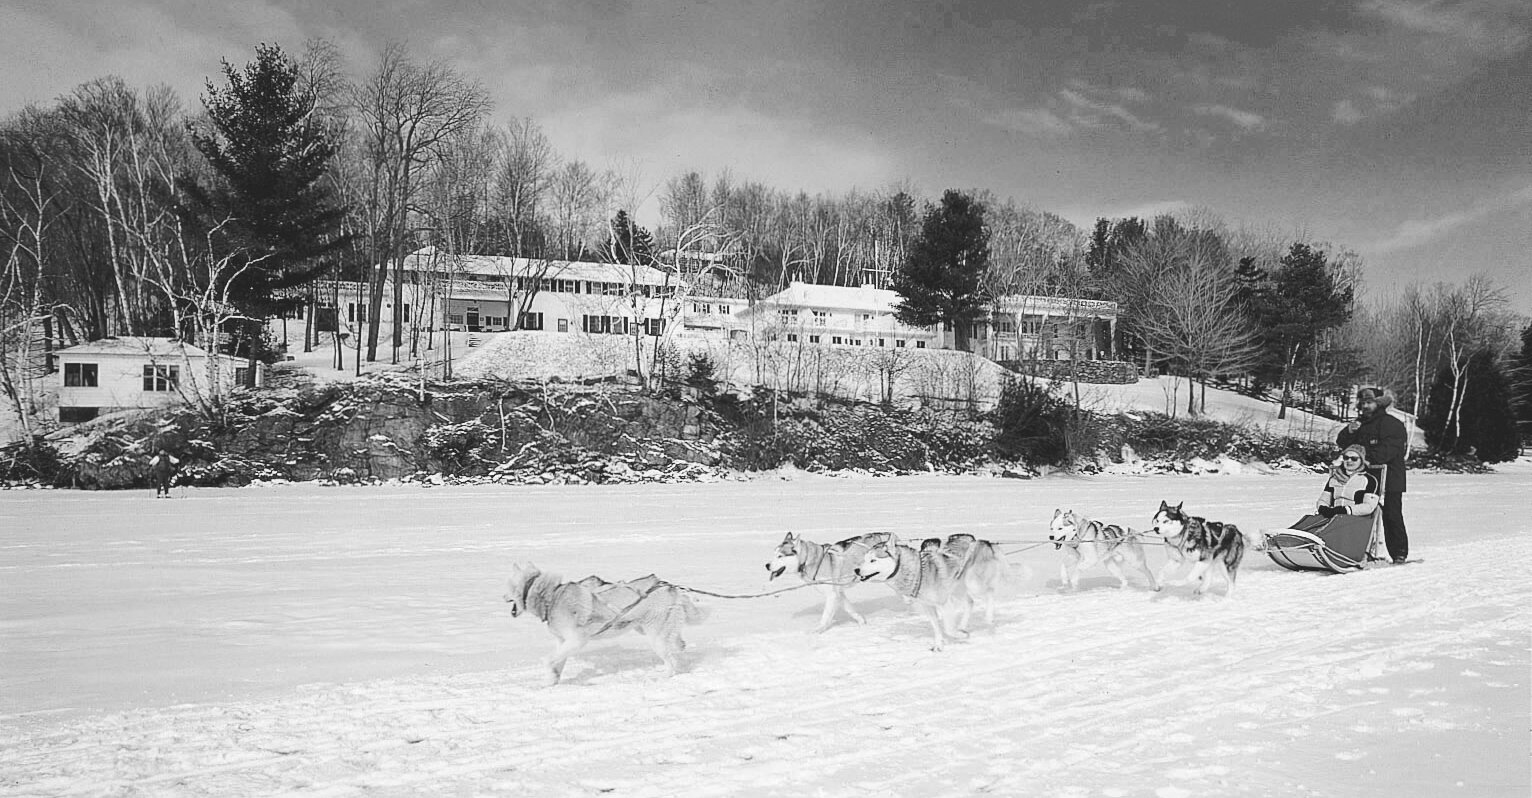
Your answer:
[0,464,1532,798]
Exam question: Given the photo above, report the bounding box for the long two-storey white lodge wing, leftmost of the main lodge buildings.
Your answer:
[319,247,679,335]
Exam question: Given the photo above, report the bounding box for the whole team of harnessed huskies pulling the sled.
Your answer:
[506,501,1244,683]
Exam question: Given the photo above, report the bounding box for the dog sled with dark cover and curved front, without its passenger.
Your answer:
[1262,466,1388,573]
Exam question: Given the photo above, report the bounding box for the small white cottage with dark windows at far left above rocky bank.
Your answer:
[54,337,262,424]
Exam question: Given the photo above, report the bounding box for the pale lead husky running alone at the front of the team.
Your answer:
[506,562,703,685]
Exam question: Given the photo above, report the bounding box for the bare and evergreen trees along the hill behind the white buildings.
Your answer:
[0,41,1532,456]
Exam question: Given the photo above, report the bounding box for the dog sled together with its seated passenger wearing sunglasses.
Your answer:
[1265,444,1383,573]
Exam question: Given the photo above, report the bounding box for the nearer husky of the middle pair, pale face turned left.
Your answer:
[855,536,971,651]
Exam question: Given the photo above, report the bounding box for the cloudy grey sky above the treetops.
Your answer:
[0,0,1532,314]
